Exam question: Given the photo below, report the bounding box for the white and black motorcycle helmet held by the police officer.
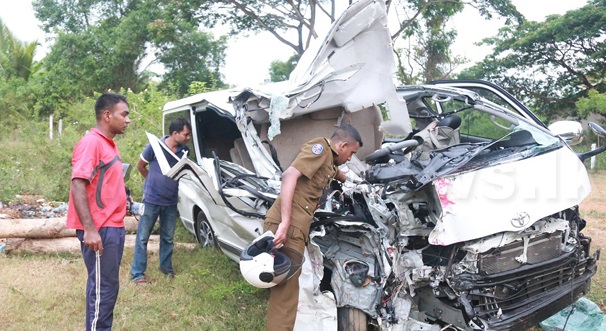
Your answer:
[240,231,303,288]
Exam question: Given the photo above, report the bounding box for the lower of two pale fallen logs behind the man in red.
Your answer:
[5,235,197,255]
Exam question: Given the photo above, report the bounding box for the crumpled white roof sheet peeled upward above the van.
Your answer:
[234,0,411,135]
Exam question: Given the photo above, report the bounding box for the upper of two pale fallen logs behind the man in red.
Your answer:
[0,216,139,239]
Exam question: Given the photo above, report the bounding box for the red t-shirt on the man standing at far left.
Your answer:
[66,128,126,230]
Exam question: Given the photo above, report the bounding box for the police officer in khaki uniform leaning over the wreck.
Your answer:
[263,125,362,331]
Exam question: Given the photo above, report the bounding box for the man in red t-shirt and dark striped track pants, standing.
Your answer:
[66,93,130,330]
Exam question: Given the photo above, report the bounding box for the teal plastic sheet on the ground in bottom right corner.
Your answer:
[539,297,606,331]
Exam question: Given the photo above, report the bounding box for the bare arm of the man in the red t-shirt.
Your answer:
[72,178,103,255]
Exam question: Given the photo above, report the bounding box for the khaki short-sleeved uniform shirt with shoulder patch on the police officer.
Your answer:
[266,138,338,241]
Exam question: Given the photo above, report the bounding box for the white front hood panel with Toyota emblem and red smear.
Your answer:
[429,147,591,246]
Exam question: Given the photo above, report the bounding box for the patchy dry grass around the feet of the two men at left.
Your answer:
[0,222,269,331]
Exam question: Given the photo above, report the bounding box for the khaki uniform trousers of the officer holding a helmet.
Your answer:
[263,222,306,331]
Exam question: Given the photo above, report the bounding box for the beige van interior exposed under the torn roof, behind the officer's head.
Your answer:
[259,106,383,169]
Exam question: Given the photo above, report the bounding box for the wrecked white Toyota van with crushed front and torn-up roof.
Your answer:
[150,0,606,330]
